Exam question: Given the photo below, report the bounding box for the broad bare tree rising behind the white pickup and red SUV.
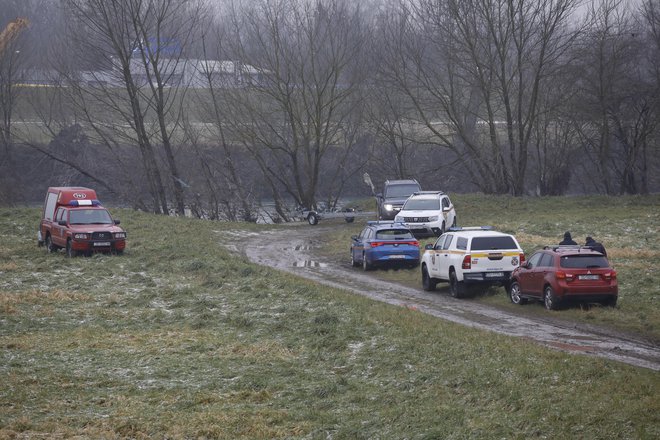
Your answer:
[378,0,576,195]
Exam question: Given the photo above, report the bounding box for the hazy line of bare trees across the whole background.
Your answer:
[0,0,660,221]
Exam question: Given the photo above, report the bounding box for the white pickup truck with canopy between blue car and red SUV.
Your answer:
[421,226,525,298]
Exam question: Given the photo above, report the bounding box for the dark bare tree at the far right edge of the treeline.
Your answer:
[575,0,658,194]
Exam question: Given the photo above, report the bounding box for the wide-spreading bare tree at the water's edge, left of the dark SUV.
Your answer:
[223,0,365,214]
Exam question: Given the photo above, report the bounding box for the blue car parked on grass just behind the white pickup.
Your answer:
[351,221,419,270]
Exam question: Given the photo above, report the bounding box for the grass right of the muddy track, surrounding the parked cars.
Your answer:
[324,194,660,343]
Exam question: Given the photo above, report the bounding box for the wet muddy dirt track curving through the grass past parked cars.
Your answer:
[235,224,660,371]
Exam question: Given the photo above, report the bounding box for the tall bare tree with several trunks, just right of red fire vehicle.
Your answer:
[61,0,208,214]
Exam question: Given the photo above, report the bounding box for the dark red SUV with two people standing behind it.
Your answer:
[509,246,619,310]
